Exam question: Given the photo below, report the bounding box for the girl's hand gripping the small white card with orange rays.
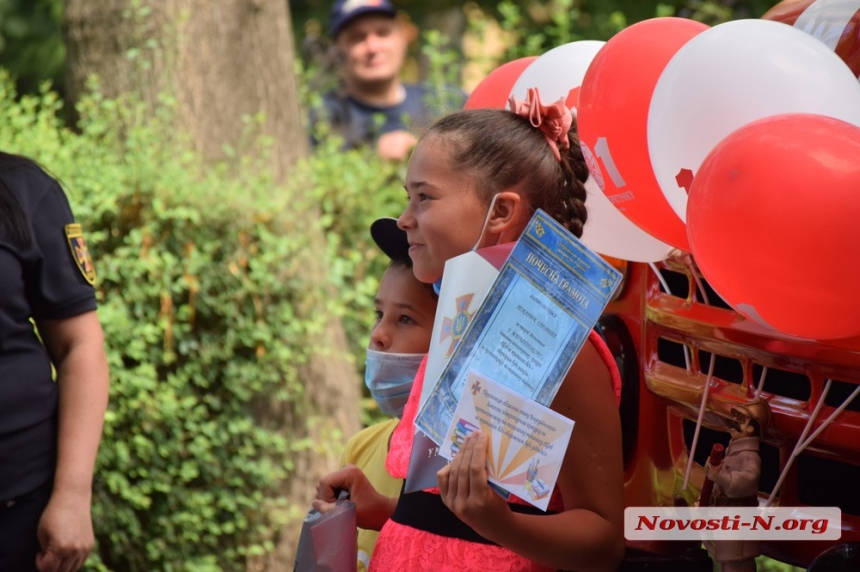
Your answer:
[436,431,511,540]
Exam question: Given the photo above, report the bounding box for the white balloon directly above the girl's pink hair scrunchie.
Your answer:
[510,40,606,103]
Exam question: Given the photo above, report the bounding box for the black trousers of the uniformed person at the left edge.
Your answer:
[0,482,53,572]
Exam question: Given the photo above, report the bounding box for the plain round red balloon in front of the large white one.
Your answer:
[687,113,860,339]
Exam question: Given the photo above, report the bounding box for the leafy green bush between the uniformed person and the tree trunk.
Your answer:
[0,73,352,572]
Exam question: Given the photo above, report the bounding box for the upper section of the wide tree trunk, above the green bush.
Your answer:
[64,0,307,175]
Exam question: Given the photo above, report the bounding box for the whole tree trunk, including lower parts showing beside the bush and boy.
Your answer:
[64,0,360,570]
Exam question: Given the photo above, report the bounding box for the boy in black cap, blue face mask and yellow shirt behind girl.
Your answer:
[341,218,438,571]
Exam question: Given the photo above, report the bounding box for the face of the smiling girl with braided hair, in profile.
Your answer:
[397,136,488,283]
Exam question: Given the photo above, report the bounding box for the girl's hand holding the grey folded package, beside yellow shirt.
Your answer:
[313,465,397,530]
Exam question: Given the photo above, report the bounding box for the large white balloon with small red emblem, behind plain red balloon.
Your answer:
[648,20,860,222]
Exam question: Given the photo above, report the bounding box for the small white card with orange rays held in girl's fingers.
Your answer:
[439,371,574,510]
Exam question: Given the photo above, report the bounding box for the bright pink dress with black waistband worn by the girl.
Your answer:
[369,331,621,572]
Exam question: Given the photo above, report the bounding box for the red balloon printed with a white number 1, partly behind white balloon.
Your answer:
[577,18,708,250]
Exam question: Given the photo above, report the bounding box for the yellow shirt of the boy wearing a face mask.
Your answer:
[341,418,403,572]
